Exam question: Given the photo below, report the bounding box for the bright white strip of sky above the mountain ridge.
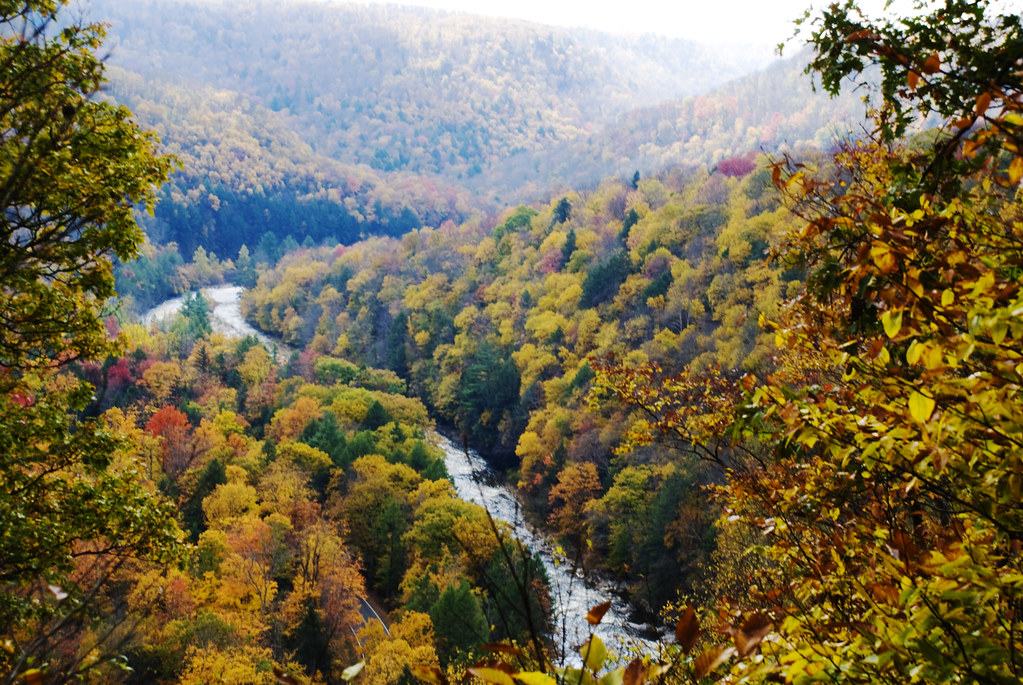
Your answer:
[349,0,863,45]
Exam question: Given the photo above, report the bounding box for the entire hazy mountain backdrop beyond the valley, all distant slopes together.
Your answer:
[88,0,862,256]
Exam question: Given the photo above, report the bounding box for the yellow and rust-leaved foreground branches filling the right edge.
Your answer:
[598,0,1023,683]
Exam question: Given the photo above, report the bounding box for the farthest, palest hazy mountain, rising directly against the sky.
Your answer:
[90,0,762,185]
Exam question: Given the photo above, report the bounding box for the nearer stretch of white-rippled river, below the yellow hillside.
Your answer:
[439,436,655,659]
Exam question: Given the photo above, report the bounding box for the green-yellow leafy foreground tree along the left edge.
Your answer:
[0,0,178,681]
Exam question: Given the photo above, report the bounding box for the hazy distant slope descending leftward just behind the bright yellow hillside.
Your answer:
[480,55,865,201]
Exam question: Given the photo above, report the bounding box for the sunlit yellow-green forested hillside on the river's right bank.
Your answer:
[243,159,800,609]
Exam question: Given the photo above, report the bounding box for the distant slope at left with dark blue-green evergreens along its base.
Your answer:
[106,67,473,258]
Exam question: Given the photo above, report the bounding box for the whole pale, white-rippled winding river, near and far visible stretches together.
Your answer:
[142,285,656,661]
